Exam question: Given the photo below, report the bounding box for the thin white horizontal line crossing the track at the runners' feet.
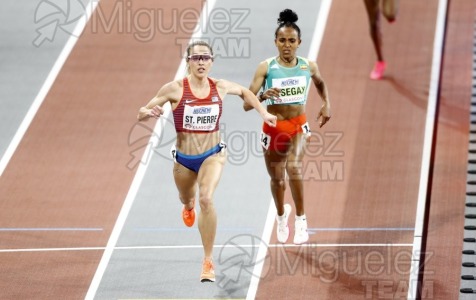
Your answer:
[0,244,413,253]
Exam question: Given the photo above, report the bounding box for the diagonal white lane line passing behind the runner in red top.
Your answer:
[85,0,216,300]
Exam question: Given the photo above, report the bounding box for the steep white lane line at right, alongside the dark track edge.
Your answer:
[407,0,448,299]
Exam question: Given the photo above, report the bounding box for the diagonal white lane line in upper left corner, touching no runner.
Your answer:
[0,0,100,177]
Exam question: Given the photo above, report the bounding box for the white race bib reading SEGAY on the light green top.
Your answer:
[273,76,307,104]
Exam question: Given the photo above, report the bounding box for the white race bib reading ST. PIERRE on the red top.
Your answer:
[183,104,220,131]
